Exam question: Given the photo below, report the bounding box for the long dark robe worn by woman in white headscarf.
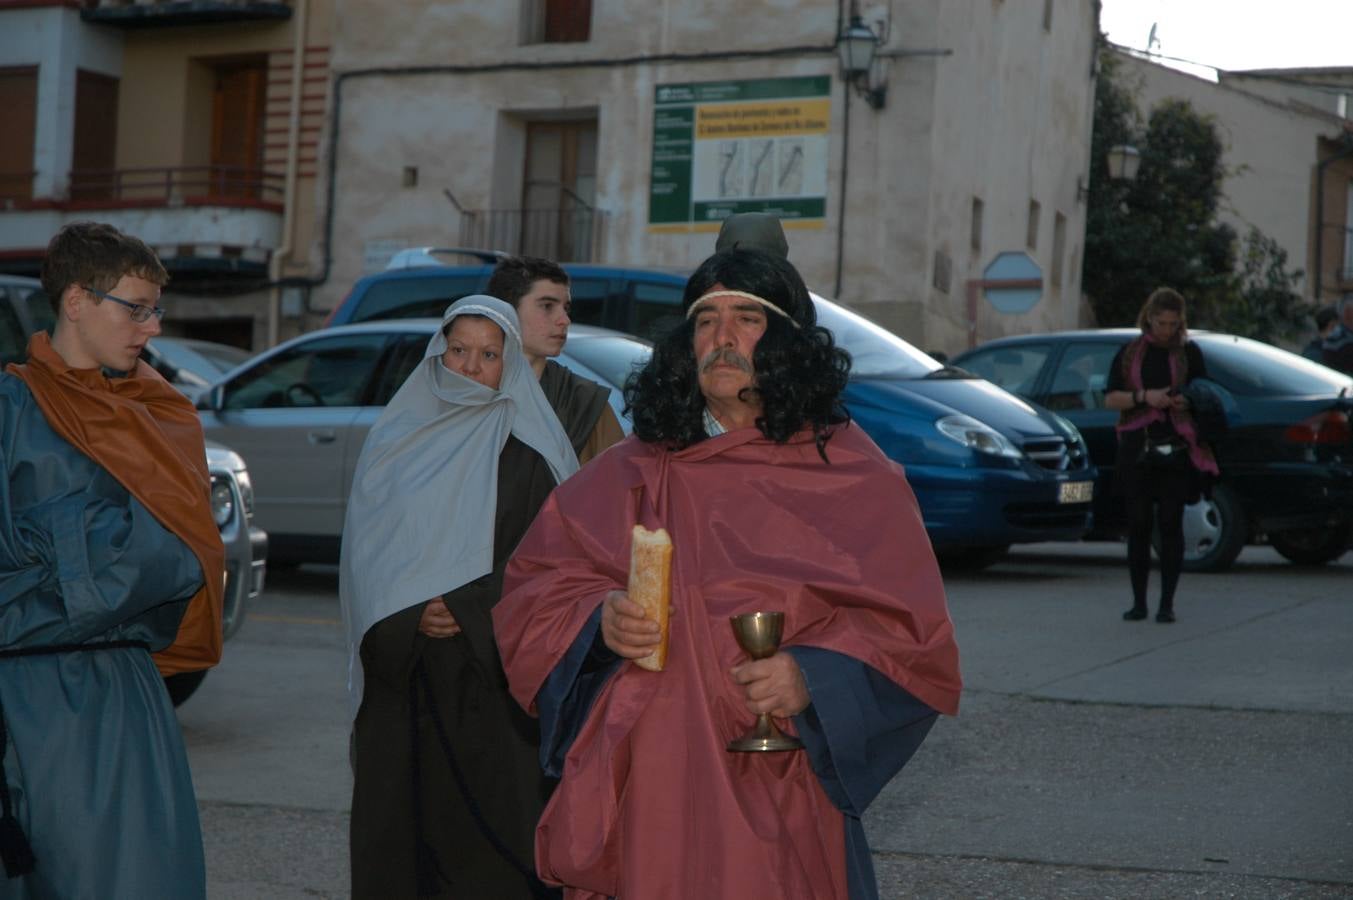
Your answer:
[352,437,555,900]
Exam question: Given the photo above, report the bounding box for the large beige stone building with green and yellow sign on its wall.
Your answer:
[322,0,1097,352]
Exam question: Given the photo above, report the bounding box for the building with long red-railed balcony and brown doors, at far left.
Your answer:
[0,0,331,348]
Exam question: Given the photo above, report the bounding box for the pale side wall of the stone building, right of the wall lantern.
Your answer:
[915,0,1096,353]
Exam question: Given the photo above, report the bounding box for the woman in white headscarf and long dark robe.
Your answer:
[340,295,578,899]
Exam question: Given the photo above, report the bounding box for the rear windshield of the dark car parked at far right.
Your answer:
[1193,334,1353,397]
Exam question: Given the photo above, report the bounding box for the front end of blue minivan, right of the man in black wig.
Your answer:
[813,294,1096,567]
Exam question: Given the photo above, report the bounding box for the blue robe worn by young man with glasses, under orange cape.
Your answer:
[0,374,206,900]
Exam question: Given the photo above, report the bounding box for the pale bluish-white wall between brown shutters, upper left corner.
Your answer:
[0,7,122,196]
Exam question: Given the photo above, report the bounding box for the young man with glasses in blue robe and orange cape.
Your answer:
[0,222,225,897]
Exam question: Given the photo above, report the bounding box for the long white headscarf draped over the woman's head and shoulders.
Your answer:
[338,294,578,715]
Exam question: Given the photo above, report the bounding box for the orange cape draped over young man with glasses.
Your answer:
[5,332,226,675]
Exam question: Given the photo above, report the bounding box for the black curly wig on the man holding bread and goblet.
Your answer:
[625,249,850,460]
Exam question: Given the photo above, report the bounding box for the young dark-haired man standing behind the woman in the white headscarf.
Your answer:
[484,256,625,464]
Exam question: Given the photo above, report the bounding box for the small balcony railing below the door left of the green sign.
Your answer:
[460,207,607,263]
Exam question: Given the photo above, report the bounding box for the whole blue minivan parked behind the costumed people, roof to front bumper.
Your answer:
[329,249,1096,567]
